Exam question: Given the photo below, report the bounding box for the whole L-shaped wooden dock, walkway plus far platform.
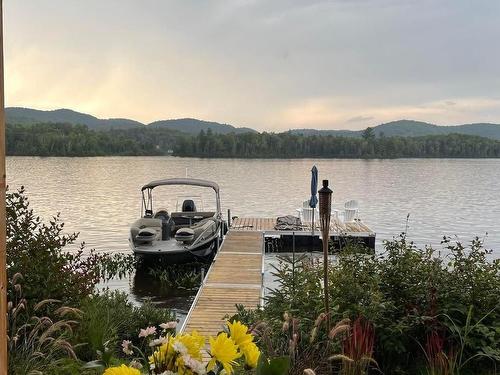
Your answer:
[181,217,375,336]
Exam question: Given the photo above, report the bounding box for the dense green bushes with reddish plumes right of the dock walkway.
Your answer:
[234,236,500,374]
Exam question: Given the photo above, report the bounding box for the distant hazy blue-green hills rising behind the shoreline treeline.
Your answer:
[5,107,500,140]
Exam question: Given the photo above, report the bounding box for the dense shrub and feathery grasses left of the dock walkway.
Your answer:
[6,188,174,374]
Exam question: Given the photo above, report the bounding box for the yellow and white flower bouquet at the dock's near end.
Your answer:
[100,321,288,375]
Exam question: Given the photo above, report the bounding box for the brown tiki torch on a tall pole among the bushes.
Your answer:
[318,180,333,332]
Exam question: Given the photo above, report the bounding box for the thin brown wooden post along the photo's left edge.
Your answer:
[0,0,8,375]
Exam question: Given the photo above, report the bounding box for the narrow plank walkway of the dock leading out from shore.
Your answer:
[181,230,263,336]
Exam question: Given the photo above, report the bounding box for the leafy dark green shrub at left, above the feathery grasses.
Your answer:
[6,187,133,306]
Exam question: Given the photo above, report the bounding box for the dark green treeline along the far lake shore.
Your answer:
[6,123,500,158]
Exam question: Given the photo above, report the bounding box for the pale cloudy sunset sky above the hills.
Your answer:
[4,0,500,131]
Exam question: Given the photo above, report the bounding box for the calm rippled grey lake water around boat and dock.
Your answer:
[7,157,500,318]
